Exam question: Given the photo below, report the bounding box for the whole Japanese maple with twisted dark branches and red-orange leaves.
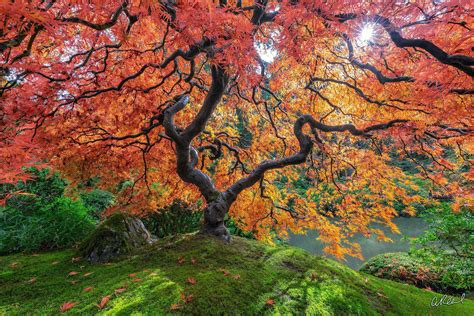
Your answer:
[0,0,474,257]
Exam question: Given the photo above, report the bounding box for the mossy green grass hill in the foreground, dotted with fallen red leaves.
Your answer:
[0,234,474,315]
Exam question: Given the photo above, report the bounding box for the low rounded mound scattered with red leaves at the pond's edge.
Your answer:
[360,252,472,294]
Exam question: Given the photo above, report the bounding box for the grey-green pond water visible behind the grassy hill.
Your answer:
[289,217,428,270]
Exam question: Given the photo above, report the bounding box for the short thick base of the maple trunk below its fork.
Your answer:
[201,194,231,242]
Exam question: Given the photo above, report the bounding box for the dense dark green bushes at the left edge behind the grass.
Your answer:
[0,169,94,254]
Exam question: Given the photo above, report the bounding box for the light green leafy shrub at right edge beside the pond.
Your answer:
[410,203,474,289]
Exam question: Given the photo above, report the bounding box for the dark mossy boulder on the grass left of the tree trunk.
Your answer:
[79,213,154,263]
